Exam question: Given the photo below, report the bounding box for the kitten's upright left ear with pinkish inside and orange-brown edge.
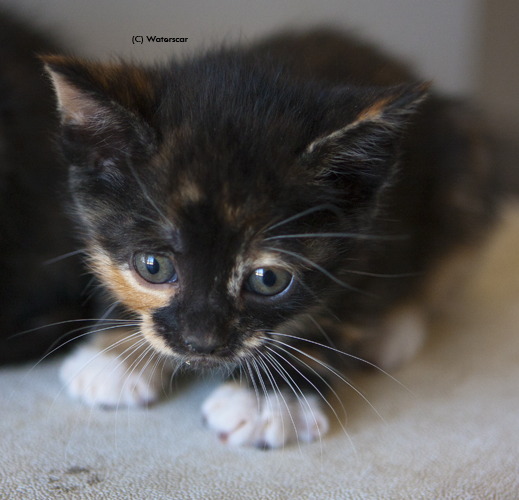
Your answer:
[40,55,156,171]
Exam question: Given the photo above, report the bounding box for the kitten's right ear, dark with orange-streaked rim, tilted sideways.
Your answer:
[303,83,430,201]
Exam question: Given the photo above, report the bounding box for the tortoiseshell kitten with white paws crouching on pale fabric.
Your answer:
[43,31,496,447]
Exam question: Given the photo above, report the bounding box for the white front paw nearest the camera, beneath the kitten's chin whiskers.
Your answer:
[202,383,329,448]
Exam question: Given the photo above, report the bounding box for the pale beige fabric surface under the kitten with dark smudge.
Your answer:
[0,205,519,500]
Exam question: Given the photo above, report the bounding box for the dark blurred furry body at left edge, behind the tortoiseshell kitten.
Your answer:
[0,12,91,364]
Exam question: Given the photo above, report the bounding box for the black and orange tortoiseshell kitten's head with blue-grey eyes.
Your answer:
[44,51,425,365]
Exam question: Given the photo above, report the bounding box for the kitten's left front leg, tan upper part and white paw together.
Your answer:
[60,328,171,407]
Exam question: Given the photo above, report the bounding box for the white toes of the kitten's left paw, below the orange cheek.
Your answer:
[60,346,162,407]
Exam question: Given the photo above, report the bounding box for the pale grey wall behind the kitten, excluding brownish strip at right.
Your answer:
[0,0,484,93]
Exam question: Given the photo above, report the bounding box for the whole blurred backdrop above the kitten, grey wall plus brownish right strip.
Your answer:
[0,0,519,138]
